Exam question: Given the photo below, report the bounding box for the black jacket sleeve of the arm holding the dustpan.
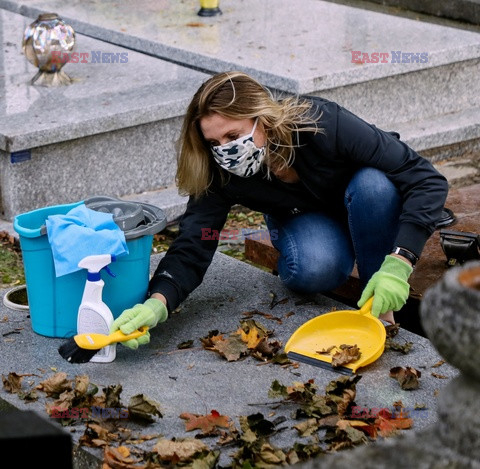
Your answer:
[336,102,448,257]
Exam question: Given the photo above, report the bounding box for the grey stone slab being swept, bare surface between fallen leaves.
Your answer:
[0,252,458,465]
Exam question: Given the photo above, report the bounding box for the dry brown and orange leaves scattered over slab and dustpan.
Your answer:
[2,316,444,469]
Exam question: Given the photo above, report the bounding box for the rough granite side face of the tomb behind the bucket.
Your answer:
[0,117,182,220]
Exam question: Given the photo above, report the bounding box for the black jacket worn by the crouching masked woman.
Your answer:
[149,97,448,310]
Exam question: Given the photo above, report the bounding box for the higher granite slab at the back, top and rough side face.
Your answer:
[0,0,480,126]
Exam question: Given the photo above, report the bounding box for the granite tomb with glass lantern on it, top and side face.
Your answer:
[0,10,207,222]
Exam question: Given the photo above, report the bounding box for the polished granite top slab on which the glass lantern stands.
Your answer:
[0,10,207,153]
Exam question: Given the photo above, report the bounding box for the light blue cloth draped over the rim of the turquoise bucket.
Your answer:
[45,204,128,277]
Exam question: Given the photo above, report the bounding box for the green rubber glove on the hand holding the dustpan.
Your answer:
[357,255,413,318]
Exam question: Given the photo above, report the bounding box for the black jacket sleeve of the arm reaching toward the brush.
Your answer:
[149,188,232,311]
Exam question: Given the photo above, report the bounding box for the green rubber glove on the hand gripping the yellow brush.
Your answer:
[110,298,168,349]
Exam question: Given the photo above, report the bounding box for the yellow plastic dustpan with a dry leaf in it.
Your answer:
[285,297,386,374]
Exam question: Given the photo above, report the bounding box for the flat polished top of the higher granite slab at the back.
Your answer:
[0,0,480,93]
